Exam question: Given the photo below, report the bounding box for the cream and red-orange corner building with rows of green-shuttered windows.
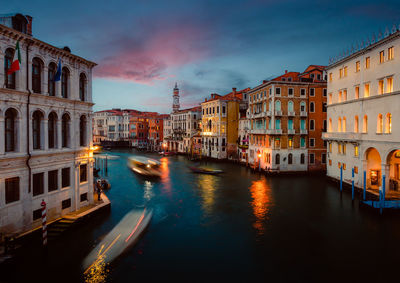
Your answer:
[248,65,327,172]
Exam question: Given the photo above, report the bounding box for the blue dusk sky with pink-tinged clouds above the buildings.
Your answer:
[0,0,400,113]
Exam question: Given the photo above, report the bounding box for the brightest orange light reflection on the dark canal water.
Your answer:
[250,177,272,235]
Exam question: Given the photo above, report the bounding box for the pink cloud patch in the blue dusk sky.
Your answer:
[94,25,209,84]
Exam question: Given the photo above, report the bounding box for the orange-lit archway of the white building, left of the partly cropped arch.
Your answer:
[364,147,382,190]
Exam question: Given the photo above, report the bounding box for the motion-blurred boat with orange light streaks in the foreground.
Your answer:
[82,208,153,276]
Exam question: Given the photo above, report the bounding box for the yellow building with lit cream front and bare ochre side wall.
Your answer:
[201,88,249,159]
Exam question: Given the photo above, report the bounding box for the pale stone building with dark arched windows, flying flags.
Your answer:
[0,14,96,235]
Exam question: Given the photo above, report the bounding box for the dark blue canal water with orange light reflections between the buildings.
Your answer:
[0,151,400,282]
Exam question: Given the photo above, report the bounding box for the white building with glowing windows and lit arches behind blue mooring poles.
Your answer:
[323,27,400,195]
